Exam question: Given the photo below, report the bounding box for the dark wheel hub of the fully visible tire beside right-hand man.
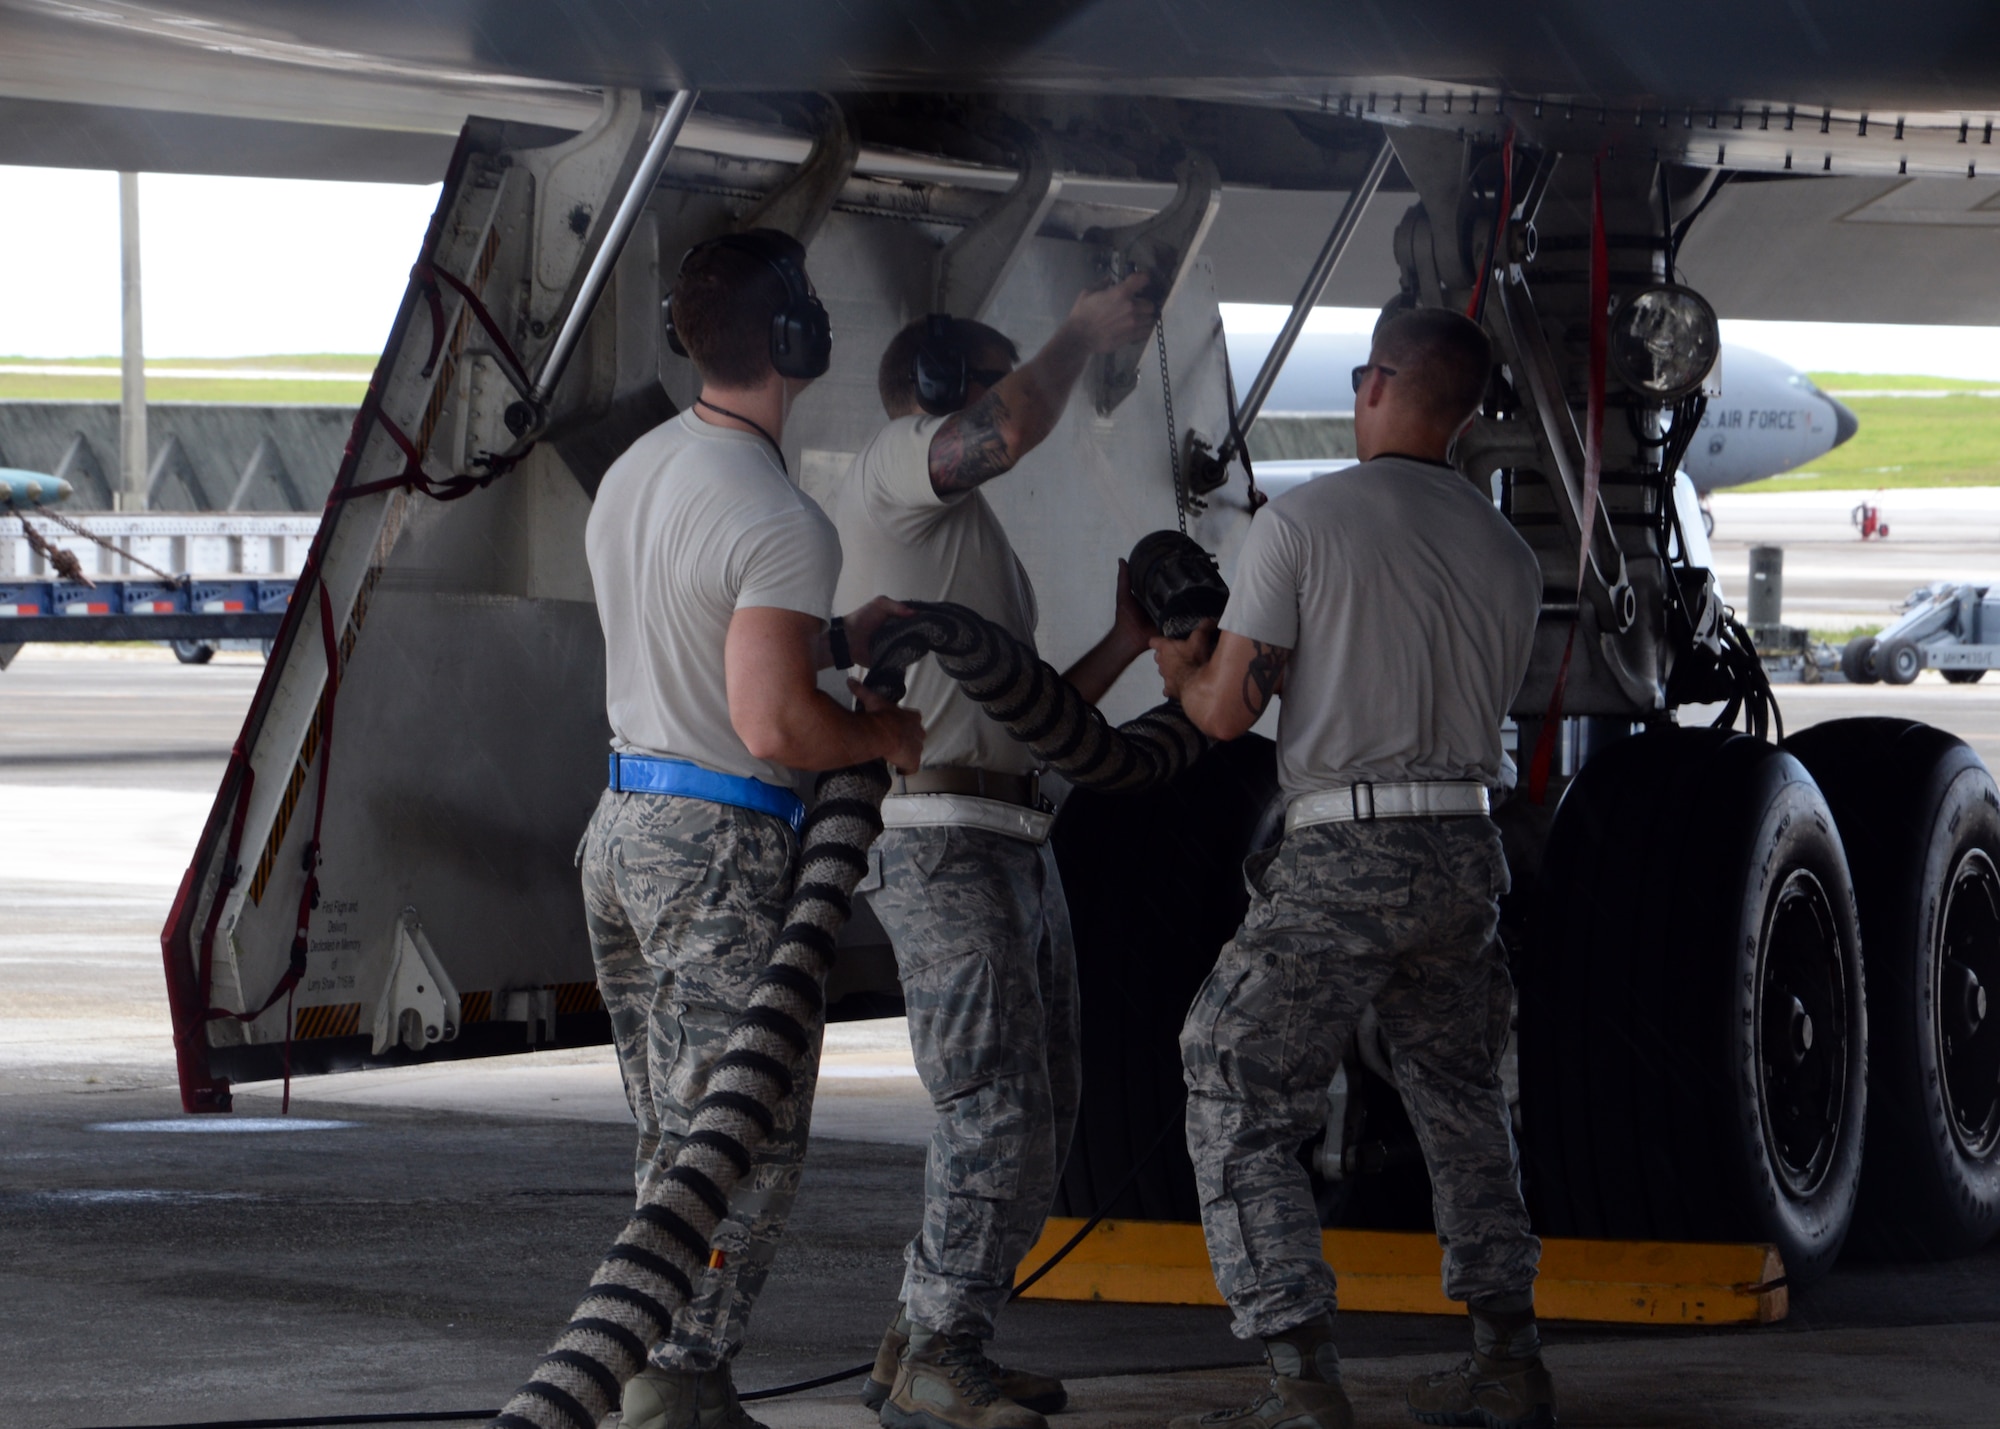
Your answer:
[1756,869,1850,1199]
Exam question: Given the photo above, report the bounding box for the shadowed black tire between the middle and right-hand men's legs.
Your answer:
[1052,737,1284,1221]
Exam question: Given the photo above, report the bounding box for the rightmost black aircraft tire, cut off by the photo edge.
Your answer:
[1786,719,2000,1257]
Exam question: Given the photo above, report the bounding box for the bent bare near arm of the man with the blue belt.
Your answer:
[722,606,924,773]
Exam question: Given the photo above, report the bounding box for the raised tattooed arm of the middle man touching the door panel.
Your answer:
[930,272,1156,496]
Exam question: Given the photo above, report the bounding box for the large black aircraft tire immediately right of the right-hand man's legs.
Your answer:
[1520,729,1868,1285]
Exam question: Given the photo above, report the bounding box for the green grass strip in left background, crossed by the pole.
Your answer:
[0,352,376,406]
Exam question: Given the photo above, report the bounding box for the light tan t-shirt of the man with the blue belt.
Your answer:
[584,412,840,787]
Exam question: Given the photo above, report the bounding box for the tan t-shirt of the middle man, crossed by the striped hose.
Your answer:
[826,416,1036,775]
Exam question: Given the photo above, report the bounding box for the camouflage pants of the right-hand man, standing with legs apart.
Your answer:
[1180,819,1542,1339]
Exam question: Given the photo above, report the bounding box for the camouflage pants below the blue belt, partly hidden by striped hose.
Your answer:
[580,791,818,1369]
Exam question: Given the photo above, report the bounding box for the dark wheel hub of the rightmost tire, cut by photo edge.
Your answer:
[1932,849,2000,1161]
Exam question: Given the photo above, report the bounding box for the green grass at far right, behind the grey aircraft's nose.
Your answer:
[1732,372,2000,490]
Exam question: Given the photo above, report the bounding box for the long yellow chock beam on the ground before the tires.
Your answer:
[1020,1219,1790,1325]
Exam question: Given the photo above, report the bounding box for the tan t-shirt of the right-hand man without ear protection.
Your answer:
[1222,456,1542,799]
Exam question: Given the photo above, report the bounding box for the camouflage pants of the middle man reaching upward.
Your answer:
[862,827,1082,1339]
